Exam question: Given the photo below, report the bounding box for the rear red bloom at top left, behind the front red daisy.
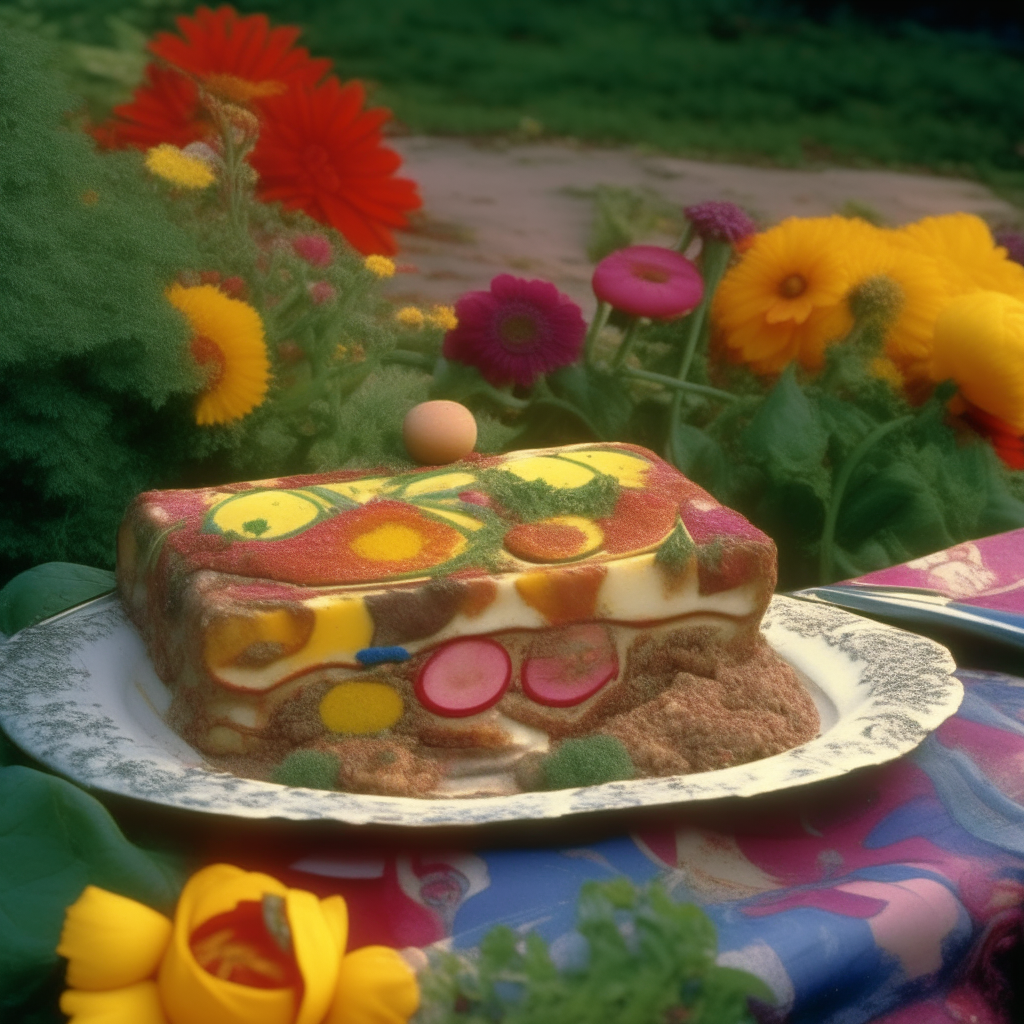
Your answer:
[93,7,331,150]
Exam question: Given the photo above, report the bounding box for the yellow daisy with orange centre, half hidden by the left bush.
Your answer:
[167,285,270,426]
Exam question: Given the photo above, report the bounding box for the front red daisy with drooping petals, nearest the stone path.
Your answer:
[251,78,422,255]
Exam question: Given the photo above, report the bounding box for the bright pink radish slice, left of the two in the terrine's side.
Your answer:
[416,638,512,718]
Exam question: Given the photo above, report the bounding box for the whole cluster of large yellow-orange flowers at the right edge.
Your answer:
[713,213,1024,428]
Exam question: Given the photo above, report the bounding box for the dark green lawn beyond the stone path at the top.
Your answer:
[6,0,1024,202]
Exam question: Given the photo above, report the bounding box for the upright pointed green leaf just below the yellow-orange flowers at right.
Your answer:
[740,364,829,497]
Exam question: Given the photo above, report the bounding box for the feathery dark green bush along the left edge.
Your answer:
[0,31,201,578]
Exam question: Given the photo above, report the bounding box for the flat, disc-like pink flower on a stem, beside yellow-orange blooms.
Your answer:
[592,246,703,319]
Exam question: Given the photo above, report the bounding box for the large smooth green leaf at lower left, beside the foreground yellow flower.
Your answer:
[0,766,184,1020]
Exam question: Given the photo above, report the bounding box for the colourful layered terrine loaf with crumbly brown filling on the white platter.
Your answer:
[118,443,818,798]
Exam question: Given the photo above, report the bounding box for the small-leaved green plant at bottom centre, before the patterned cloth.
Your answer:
[414,879,774,1024]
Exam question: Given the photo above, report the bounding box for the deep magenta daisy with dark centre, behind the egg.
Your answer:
[443,273,587,386]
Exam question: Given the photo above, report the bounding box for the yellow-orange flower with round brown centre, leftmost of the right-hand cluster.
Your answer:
[713,217,859,373]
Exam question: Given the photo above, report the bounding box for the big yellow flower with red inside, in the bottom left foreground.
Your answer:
[58,864,419,1024]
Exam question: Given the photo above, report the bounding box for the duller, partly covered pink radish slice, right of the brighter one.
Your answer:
[522,625,618,708]
